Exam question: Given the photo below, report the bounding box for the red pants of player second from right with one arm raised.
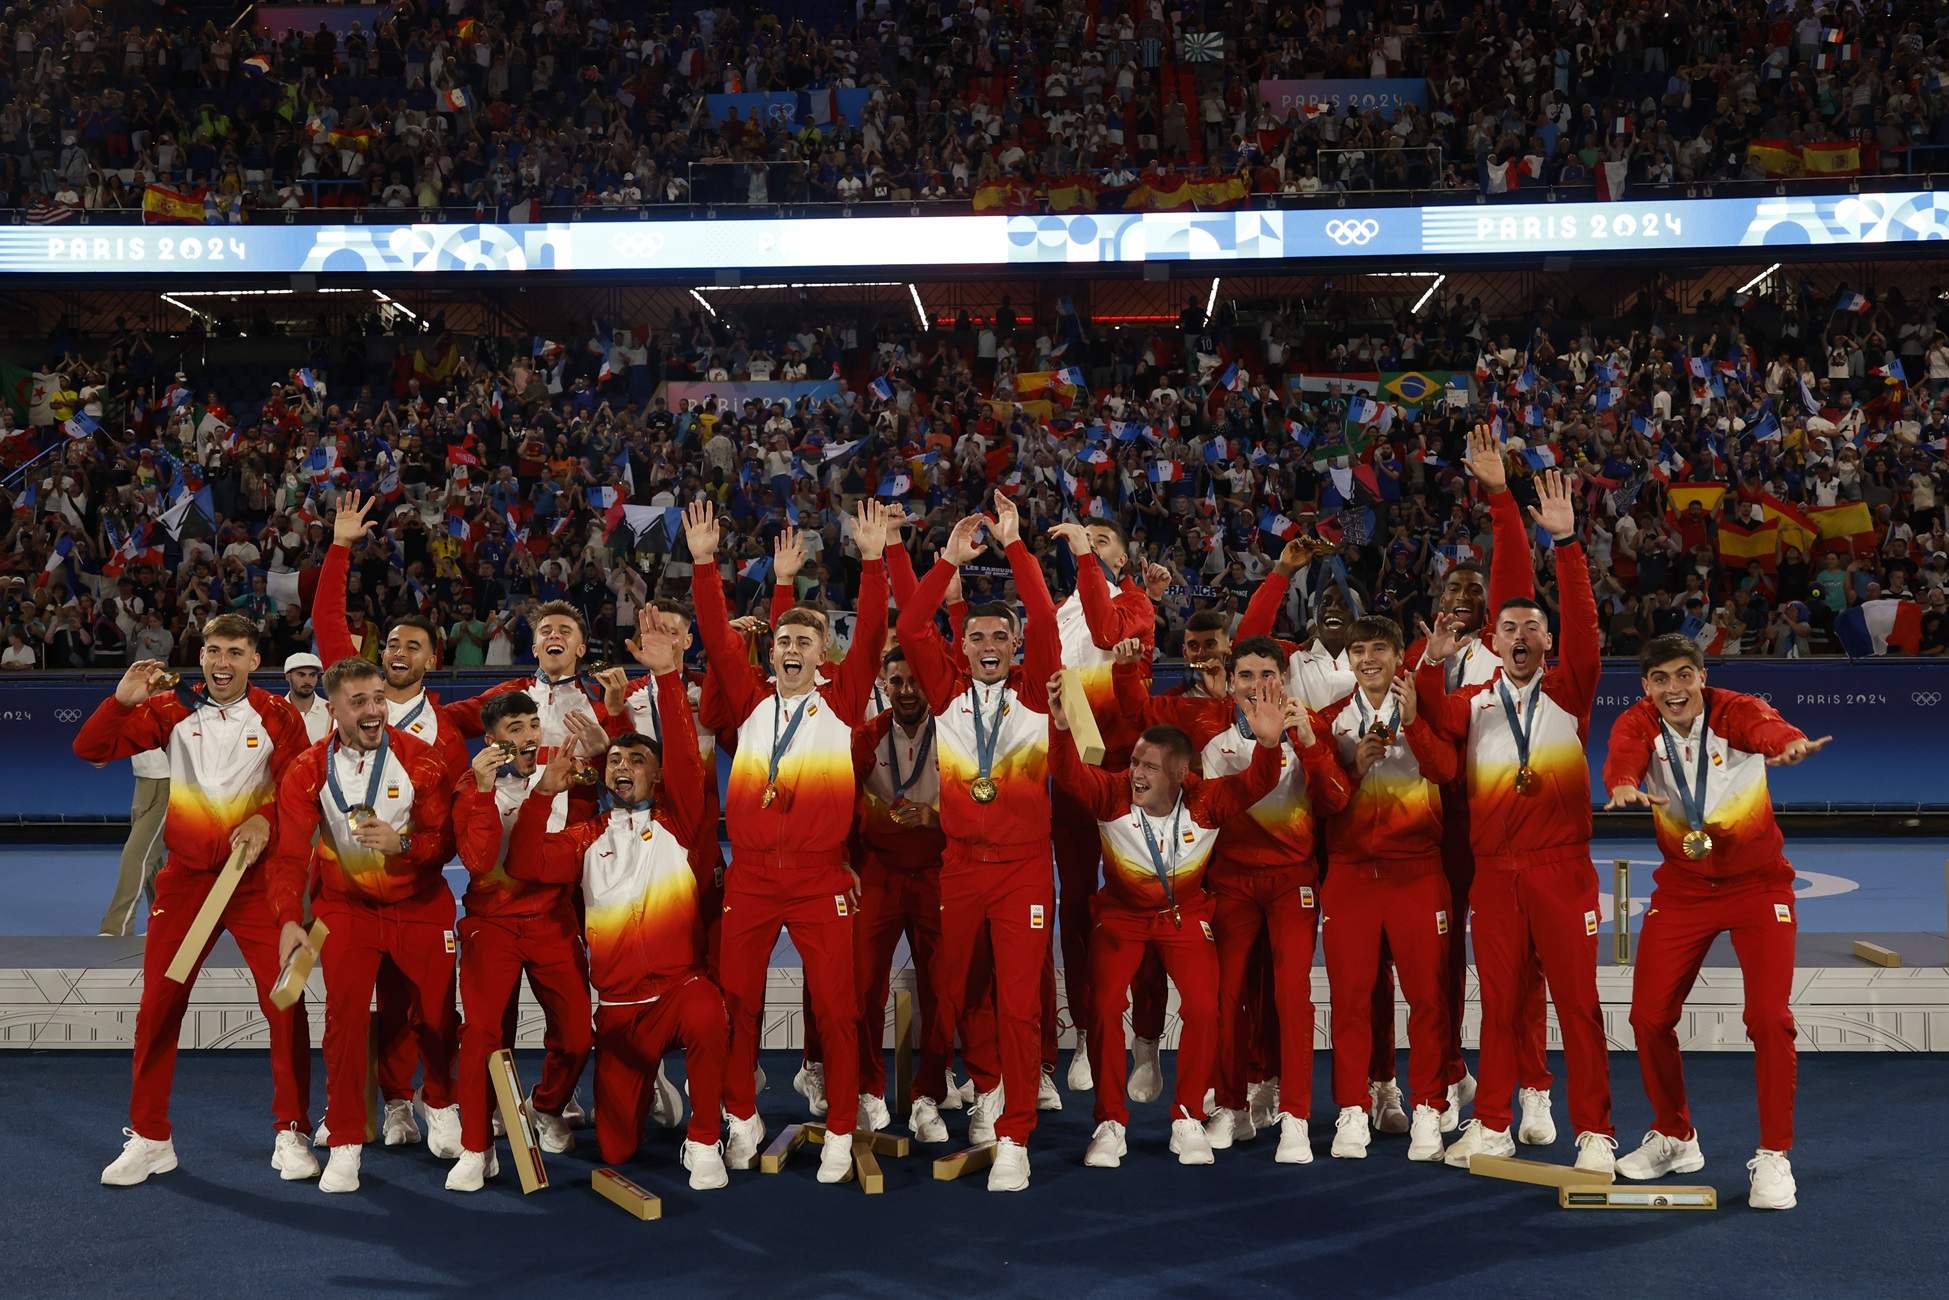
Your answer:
[1471,846,1614,1136]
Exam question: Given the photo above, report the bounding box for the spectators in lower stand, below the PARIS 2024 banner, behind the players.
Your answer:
[0,277,1949,667]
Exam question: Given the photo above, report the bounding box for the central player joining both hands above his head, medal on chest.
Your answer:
[898,493,1062,1191]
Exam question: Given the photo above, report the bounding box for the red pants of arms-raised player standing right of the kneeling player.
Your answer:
[717,861,860,1136]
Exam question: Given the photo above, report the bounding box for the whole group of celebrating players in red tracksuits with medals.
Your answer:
[74,429,1826,1208]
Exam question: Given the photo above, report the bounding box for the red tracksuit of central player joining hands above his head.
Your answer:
[898,542,1076,1144]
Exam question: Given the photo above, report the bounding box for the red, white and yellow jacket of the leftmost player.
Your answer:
[74,686,306,871]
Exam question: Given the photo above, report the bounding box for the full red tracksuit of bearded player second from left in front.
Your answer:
[269,727,460,1146]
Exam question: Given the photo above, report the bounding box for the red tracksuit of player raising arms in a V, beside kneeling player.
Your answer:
[693,559,887,1136]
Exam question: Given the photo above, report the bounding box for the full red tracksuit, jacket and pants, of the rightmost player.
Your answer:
[1604,686,1807,1152]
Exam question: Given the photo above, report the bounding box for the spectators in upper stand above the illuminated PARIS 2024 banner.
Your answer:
[0,0,1949,222]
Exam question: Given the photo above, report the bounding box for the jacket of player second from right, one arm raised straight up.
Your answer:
[1415,540,1600,871]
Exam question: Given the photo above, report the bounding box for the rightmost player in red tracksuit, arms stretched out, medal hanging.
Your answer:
[1604,635,1834,1210]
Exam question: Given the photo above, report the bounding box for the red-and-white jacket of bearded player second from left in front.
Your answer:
[269,727,454,924]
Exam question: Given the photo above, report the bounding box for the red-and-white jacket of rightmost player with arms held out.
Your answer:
[1604,686,1807,889]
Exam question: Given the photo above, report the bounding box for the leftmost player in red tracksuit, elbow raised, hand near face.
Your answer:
[74,627,318,1187]
